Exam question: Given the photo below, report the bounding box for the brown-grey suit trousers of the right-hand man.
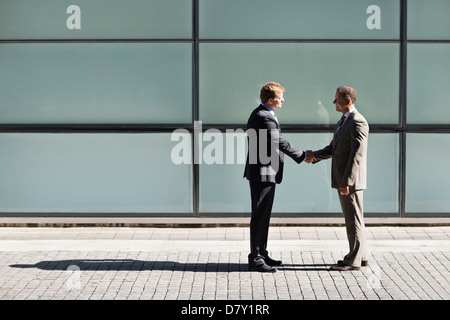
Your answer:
[338,190,367,267]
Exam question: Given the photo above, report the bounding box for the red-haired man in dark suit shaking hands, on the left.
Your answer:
[244,82,305,272]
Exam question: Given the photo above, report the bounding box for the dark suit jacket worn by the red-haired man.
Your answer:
[244,105,305,183]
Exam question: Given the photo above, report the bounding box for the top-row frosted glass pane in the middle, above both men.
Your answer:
[199,0,400,39]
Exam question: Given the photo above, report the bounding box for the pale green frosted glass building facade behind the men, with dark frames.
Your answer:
[0,0,450,217]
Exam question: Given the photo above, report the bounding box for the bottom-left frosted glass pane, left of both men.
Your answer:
[0,133,192,215]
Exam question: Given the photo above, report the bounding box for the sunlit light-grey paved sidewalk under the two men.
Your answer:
[0,226,450,300]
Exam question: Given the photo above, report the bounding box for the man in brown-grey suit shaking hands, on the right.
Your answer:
[306,86,369,271]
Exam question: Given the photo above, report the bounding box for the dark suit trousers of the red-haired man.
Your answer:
[250,181,276,259]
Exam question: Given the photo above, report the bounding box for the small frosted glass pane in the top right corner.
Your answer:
[407,0,450,40]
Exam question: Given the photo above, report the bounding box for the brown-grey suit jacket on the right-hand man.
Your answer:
[314,109,369,190]
